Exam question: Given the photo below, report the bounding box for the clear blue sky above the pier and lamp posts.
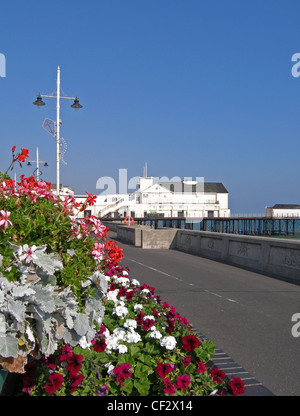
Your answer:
[0,0,300,213]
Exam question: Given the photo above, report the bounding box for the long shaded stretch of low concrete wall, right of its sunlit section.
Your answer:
[175,230,300,283]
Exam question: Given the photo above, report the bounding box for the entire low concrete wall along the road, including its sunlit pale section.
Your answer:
[102,223,300,284]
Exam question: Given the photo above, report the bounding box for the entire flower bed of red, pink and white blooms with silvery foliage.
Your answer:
[0,148,244,396]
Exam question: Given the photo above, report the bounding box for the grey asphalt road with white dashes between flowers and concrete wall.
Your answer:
[110,233,300,396]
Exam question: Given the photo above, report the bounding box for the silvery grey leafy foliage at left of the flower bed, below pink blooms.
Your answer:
[0,245,107,368]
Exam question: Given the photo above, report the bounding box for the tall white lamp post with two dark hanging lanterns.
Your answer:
[33,66,82,196]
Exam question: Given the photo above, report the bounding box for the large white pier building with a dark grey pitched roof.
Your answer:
[75,177,230,218]
